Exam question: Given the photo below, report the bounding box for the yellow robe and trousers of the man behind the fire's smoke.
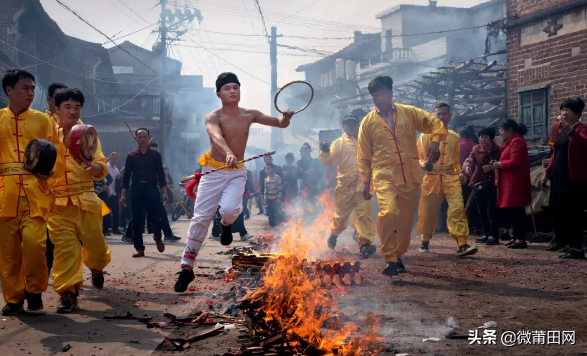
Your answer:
[319,133,375,246]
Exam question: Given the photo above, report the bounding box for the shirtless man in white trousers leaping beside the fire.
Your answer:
[175,73,294,293]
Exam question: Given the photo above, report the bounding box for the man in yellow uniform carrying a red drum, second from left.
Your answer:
[48,89,111,313]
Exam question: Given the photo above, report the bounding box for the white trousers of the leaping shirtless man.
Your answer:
[181,167,247,267]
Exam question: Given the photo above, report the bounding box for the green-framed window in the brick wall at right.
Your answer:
[520,88,548,139]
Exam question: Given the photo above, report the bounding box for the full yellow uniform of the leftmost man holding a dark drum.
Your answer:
[0,108,59,303]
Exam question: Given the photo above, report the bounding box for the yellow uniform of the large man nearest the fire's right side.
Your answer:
[358,104,446,262]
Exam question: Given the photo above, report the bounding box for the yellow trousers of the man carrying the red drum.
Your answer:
[48,204,111,295]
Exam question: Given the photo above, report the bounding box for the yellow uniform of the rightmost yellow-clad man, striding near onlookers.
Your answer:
[418,130,469,247]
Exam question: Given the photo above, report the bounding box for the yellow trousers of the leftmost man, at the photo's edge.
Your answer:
[0,197,48,303]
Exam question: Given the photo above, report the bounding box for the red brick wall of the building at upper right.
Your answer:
[507,0,587,138]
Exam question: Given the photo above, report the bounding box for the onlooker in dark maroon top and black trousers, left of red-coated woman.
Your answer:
[463,127,501,245]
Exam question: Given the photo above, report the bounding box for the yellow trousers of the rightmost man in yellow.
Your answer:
[417,187,469,247]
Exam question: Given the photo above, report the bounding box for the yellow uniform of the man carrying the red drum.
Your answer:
[48,129,110,295]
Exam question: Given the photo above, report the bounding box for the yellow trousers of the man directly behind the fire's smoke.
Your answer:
[330,183,375,246]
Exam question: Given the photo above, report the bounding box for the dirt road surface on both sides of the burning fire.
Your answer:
[0,213,587,356]
